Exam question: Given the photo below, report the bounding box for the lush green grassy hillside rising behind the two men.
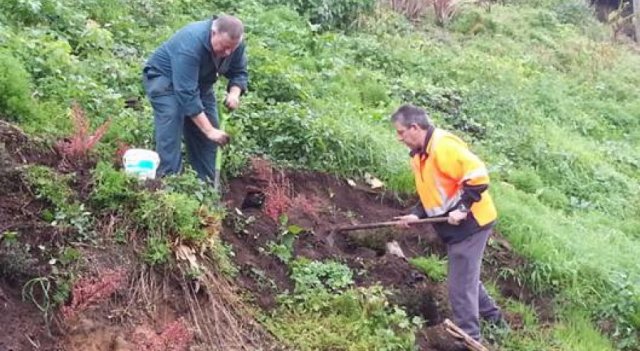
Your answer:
[0,0,640,350]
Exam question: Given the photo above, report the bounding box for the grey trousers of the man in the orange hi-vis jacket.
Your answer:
[447,229,502,340]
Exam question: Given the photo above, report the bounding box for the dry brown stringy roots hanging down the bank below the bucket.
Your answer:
[125,260,278,351]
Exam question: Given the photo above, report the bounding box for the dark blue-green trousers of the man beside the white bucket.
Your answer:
[142,67,218,180]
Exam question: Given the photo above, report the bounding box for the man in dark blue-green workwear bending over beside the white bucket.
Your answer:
[143,16,248,180]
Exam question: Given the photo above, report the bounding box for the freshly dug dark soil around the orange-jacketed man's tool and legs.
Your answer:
[223,160,544,350]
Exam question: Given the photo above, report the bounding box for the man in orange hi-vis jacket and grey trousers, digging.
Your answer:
[391,105,504,340]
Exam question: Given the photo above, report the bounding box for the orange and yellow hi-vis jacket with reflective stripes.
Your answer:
[411,128,497,243]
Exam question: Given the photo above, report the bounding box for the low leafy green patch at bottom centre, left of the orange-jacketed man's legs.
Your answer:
[264,258,419,351]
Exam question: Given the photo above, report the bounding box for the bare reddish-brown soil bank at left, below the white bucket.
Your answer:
[0,121,198,351]
